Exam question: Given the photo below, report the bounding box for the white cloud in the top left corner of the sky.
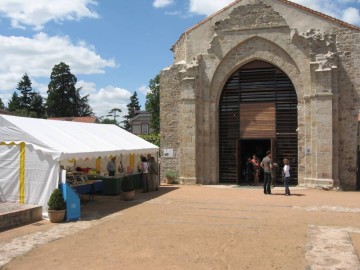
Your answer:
[0,0,98,30]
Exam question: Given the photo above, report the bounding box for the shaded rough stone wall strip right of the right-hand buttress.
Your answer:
[334,28,360,190]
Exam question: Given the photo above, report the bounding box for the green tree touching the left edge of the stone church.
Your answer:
[145,75,160,133]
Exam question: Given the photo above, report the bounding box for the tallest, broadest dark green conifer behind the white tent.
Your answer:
[46,62,92,117]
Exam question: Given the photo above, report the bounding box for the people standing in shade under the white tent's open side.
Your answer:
[107,154,160,193]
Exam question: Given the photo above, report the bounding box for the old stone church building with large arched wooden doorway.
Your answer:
[160,0,360,190]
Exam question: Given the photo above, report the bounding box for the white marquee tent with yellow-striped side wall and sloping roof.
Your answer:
[0,115,159,213]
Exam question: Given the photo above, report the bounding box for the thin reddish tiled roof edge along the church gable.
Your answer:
[172,0,360,49]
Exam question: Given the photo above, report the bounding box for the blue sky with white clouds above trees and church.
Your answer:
[0,0,360,121]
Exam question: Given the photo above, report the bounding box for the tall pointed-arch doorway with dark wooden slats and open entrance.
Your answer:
[219,61,298,184]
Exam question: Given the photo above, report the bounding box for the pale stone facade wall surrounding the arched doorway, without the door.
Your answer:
[160,0,360,189]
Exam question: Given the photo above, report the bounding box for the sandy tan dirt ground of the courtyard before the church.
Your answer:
[0,185,360,270]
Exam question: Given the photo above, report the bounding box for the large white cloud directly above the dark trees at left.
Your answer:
[0,33,116,90]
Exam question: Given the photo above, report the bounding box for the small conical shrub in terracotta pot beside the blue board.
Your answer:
[48,188,66,223]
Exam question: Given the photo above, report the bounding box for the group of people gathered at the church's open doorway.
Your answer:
[245,151,290,196]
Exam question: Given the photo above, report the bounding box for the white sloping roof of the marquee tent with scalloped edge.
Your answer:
[0,115,159,160]
